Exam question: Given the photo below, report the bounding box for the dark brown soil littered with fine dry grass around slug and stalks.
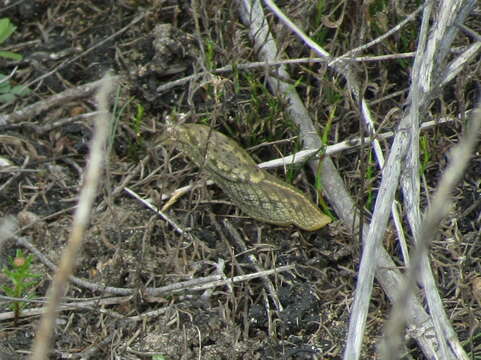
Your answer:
[0,0,481,360]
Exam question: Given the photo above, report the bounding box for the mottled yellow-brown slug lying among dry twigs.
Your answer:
[167,124,331,231]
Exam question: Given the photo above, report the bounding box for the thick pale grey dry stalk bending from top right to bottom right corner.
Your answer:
[392,0,474,359]
